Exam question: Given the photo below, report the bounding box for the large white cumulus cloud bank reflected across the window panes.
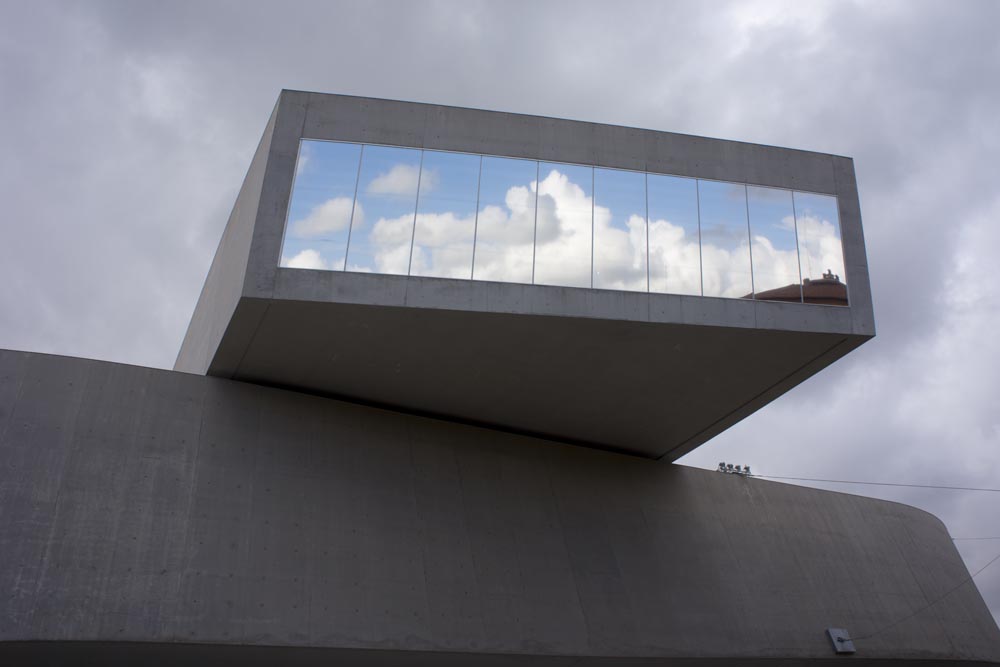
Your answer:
[352,169,812,298]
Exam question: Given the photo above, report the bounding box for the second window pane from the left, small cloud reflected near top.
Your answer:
[347,146,420,274]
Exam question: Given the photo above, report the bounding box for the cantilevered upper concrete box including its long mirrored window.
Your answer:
[176,92,875,461]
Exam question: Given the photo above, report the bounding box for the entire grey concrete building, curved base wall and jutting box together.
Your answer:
[0,91,1000,665]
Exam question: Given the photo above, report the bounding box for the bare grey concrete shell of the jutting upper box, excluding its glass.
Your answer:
[175,91,875,460]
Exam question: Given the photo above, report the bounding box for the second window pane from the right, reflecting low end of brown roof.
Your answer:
[747,185,802,301]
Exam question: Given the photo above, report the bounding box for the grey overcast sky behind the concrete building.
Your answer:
[0,0,1000,632]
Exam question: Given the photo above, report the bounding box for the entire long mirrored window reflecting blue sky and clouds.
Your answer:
[281,140,847,305]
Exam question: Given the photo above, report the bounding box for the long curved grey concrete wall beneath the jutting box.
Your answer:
[0,352,1000,665]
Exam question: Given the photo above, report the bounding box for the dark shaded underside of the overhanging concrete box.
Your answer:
[219,296,859,461]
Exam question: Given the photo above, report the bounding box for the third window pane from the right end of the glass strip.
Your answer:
[698,181,753,298]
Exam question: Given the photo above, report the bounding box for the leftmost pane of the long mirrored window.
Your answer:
[281,140,361,271]
